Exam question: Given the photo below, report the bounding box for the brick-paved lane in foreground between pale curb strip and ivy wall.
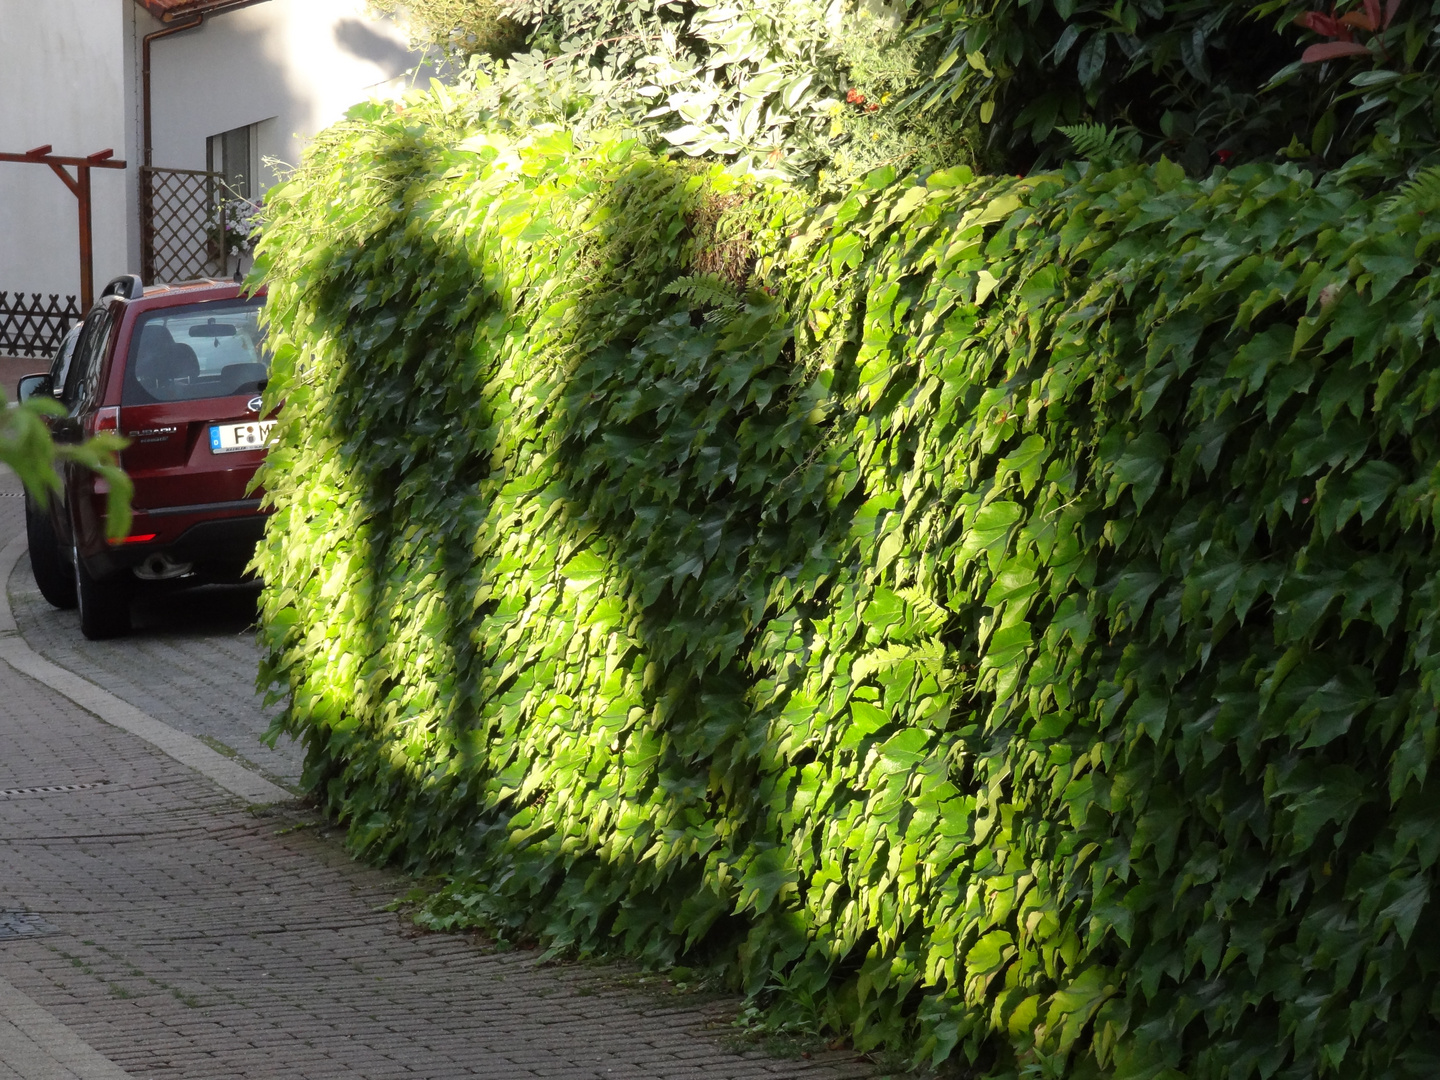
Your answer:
[0,481,870,1080]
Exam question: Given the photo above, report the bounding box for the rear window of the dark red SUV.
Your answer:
[121,297,269,405]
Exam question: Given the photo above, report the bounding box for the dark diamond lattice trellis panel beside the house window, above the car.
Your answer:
[140,167,225,285]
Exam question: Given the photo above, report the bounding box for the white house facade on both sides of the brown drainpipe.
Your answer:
[0,0,425,305]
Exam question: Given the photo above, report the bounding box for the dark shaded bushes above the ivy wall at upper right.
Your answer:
[914,0,1440,179]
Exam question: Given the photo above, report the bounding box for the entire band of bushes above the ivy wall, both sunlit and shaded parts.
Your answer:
[377,0,1440,185]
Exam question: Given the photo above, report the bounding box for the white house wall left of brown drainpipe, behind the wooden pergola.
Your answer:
[0,0,138,295]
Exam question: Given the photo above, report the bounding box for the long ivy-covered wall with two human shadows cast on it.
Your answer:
[259,97,1440,1077]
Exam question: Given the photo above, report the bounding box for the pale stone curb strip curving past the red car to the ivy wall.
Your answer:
[0,533,295,804]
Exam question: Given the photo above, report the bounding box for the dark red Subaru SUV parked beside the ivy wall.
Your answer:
[19,275,274,638]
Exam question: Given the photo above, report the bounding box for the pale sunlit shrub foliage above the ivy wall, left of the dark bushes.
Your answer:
[384,0,975,192]
